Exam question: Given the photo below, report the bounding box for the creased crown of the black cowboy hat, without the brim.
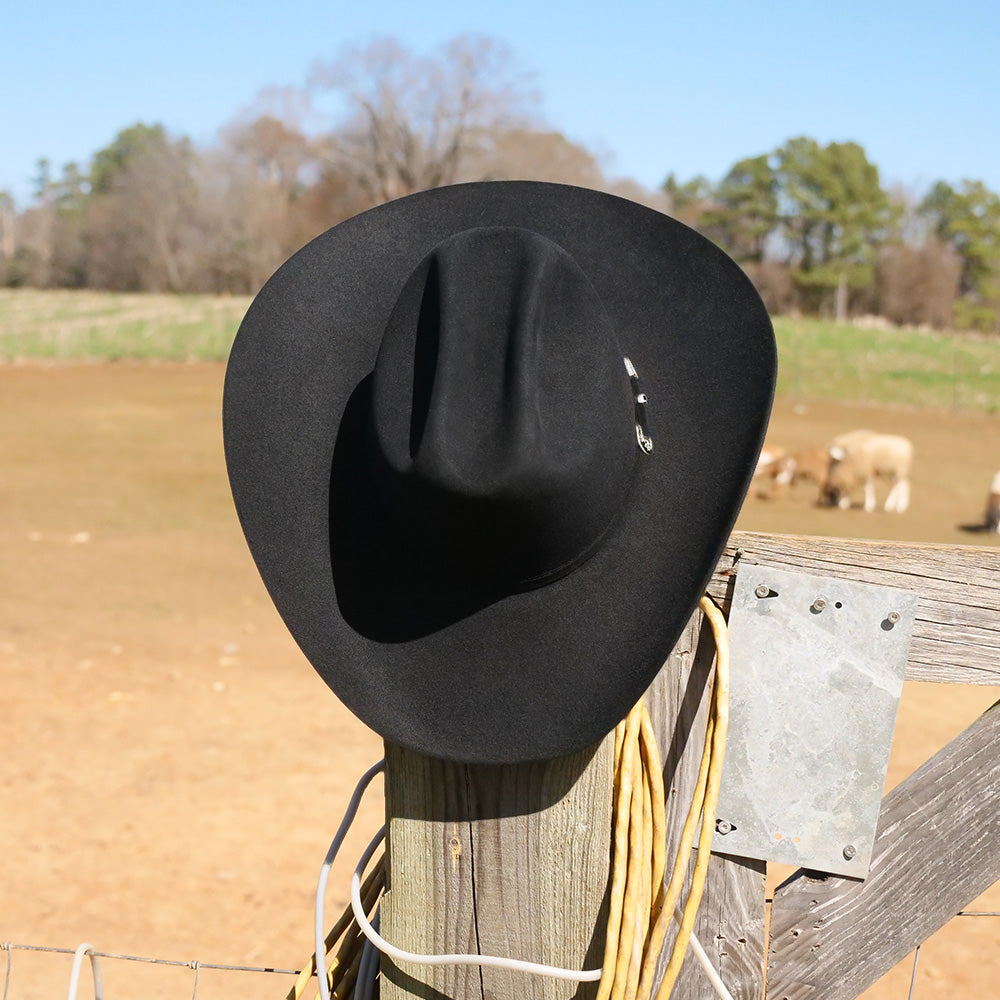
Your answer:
[371,227,637,592]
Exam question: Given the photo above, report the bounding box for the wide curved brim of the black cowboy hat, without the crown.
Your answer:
[223,181,777,763]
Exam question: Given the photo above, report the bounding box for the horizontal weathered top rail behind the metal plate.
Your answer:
[709,531,1000,684]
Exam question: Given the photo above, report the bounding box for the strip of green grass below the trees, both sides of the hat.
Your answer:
[0,289,1000,413]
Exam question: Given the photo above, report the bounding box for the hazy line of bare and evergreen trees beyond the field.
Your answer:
[0,36,1000,333]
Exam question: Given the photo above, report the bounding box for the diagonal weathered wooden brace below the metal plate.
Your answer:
[767,702,1000,1000]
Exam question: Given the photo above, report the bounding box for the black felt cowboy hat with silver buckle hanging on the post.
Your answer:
[223,181,776,763]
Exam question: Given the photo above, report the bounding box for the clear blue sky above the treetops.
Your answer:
[0,0,1000,206]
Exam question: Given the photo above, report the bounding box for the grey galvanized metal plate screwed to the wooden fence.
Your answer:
[712,563,917,878]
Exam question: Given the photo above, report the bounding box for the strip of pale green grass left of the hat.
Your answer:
[0,288,250,361]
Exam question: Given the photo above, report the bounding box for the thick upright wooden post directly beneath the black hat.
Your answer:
[382,736,614,1000]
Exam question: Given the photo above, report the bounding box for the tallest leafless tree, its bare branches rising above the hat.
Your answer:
[308,36,533,204]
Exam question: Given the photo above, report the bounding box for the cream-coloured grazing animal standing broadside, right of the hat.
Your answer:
[822,430,913,514]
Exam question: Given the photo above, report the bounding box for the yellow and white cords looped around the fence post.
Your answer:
[294,596,732,1000]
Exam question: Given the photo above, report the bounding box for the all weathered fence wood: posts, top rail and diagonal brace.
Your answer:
[382,532,1000,1000]
